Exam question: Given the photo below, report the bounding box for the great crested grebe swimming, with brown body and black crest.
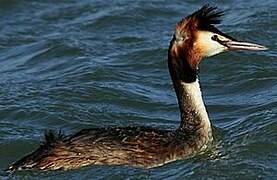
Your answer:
[7,5,266,171]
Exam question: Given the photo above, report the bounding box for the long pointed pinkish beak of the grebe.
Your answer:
[223,40,268,51]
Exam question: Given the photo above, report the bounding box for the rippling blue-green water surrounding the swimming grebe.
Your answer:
[0,0,277,179]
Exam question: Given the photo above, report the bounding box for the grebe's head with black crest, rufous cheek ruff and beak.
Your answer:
[170,5,267,69]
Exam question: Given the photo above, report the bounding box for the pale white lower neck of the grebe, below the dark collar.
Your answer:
[178,79,212,138]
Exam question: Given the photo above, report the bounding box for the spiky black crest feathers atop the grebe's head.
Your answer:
[189,4,224,27]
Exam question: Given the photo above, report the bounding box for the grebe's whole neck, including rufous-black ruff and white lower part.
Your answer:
[168,39,212,141]
